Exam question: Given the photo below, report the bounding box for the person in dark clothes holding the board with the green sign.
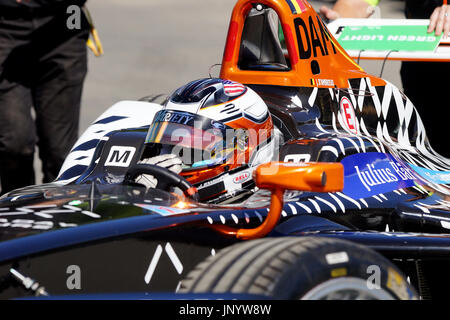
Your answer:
[319,0,450,158]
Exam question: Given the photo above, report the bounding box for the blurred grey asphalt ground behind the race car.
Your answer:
[35,0,404,183]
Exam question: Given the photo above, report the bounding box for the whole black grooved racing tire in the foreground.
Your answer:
[178,237,417,300]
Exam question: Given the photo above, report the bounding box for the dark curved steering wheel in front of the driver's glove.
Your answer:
[124,164,199,201]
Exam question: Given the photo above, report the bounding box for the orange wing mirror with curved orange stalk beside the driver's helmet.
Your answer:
[211,162,344,240]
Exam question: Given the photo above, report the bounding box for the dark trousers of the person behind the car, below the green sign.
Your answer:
[400,62,450,158]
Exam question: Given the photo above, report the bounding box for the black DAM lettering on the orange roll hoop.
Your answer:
[294,16,336,59]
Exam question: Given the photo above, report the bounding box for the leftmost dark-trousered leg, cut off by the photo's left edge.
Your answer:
[0,12,35,194]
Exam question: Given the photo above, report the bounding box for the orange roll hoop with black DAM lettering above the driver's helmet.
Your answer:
[220,0,386,88]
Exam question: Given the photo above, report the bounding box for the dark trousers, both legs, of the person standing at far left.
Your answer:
[0,8,89,193]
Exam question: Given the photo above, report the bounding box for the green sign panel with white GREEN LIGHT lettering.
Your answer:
[338,25,442,52]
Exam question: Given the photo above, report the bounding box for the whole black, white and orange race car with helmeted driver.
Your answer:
[0,0,450,299]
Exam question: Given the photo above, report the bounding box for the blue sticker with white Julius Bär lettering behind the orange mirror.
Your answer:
[341,152,421,199]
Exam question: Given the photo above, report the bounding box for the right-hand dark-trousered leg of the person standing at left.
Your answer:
[33,11,88,182]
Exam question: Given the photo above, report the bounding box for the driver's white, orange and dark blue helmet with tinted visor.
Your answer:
[146,79,275,203]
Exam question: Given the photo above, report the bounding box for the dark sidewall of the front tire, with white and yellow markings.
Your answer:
[269,240,417,300]
